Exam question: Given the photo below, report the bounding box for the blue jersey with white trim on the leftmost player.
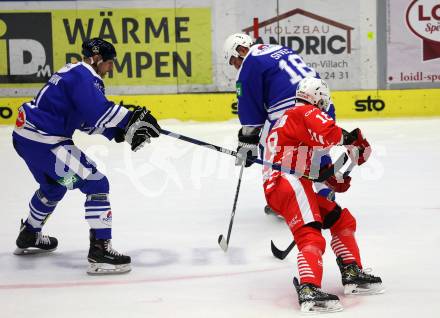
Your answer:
[14,62,131,144]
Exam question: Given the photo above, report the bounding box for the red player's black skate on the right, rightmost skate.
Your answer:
[336,257,385,295]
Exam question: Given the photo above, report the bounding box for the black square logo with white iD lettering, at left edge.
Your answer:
[0,12,53,83]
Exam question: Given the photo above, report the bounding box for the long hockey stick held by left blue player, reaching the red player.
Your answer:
[160,129,348,182]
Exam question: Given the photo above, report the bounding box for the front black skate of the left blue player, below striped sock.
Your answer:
[87,230,131,275]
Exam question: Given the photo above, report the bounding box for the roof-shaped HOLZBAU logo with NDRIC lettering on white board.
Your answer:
[242,8,354,55]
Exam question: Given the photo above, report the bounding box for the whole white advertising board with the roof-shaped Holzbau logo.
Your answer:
[214,0,376,90]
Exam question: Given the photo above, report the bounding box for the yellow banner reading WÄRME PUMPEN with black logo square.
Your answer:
[0,8,213,87]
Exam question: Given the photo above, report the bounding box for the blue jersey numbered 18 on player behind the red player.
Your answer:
[236,44,334,127]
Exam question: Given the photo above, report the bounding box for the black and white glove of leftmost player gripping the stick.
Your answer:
[124,106,160,151]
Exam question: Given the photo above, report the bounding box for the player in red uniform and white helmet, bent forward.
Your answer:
[264,77,383,312]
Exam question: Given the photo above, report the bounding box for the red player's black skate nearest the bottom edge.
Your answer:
[293,277,344,313]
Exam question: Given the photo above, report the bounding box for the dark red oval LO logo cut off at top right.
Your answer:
[406,0,440,61]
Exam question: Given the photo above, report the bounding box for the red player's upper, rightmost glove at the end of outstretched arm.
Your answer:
[342,128,371,166]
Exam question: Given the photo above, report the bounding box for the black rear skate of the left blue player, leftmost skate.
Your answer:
[14,220,58,255]
